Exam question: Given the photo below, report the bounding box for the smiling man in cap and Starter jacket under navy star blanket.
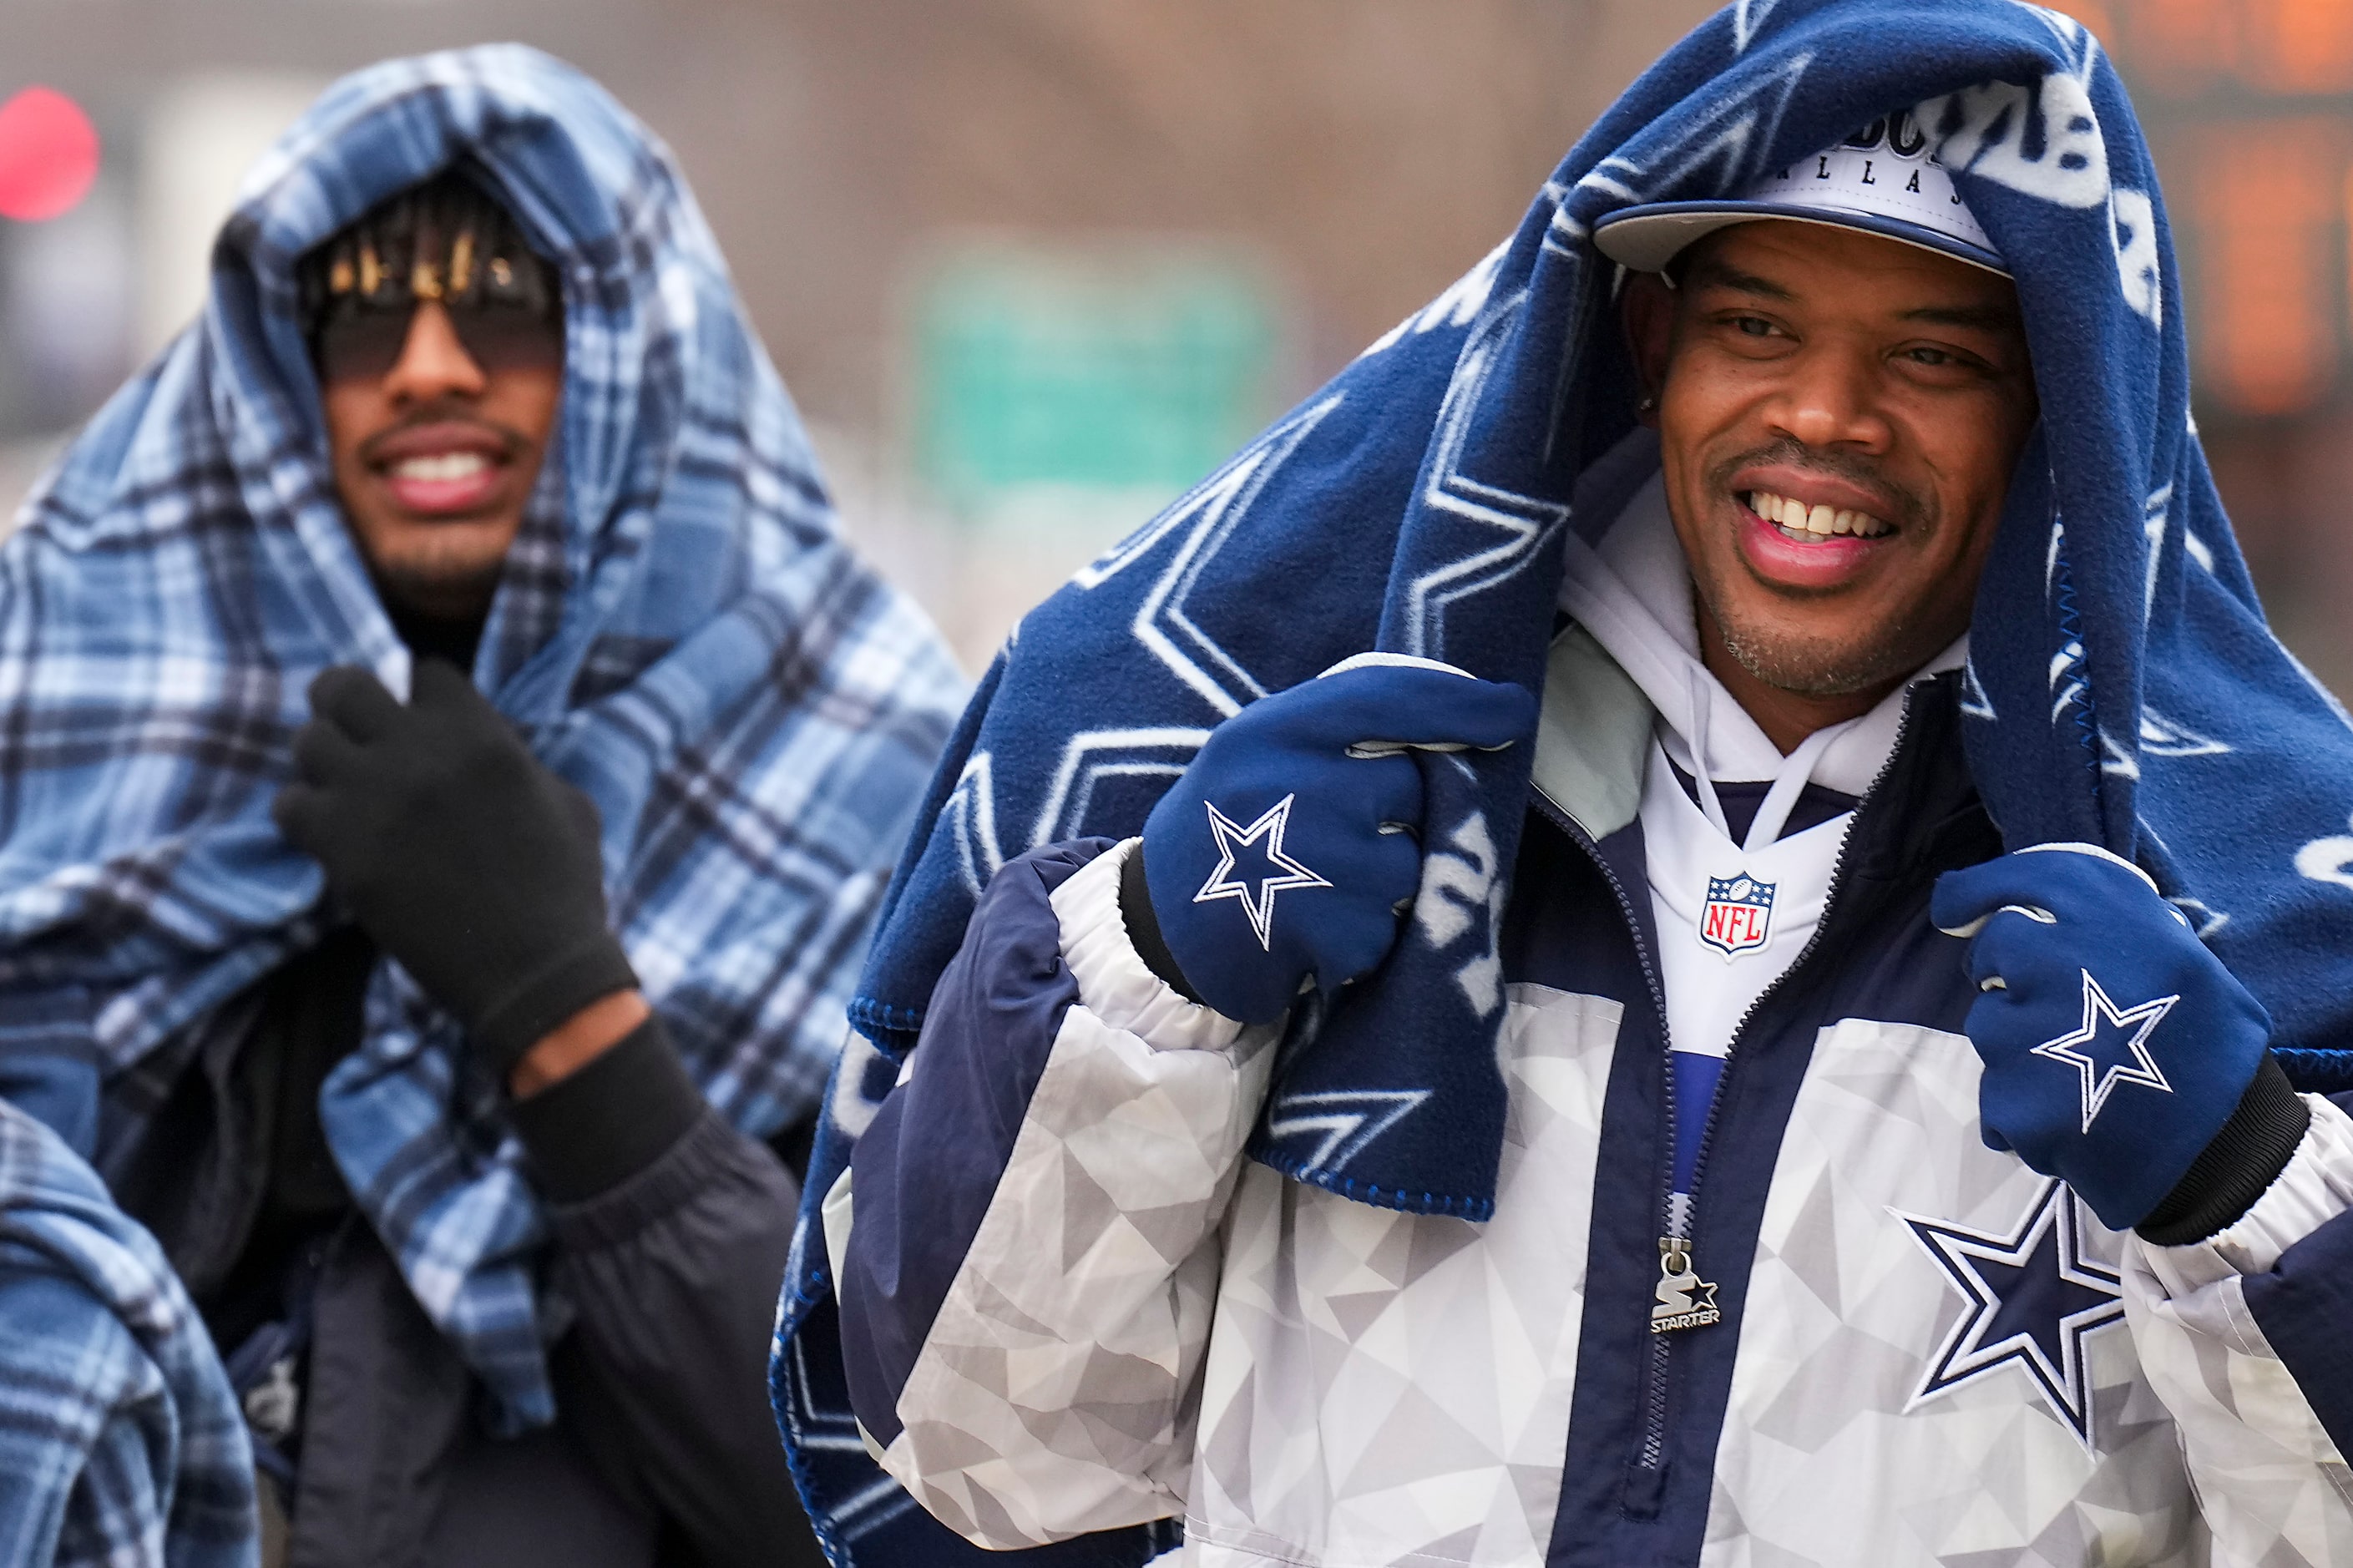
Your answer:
[777,0,2353,1568]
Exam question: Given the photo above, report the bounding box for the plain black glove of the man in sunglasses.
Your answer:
[271,660,638,1080]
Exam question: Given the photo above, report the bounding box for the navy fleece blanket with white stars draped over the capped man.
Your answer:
[779,0,2353,1563]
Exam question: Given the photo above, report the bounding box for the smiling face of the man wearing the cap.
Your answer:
[1610,222,2036,751]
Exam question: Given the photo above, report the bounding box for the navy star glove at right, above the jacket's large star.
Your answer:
[1930,842,2308,1241]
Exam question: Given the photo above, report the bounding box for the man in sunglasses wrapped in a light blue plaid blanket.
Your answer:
[0,47,963,1568]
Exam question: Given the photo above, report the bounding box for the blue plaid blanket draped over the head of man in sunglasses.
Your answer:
[0,47,963,1424]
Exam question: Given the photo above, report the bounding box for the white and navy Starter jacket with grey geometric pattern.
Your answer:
[823,626,2353,1568]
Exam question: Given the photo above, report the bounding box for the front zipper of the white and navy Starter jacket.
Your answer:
[1530,685,1918,1479]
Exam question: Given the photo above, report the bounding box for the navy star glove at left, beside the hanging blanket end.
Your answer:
[1122,655,1536,1024]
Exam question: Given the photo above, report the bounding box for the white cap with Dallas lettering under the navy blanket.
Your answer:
[1593,113,2010,278]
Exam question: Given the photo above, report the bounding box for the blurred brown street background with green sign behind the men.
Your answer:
[0,0,2353,692]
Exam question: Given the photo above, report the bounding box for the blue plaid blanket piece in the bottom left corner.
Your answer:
[0,1100,261,1568]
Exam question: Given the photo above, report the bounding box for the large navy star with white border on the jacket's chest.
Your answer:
[1887,1180,2125,1448]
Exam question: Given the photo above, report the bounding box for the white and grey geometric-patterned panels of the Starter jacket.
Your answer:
[828,638,2353,1568]
